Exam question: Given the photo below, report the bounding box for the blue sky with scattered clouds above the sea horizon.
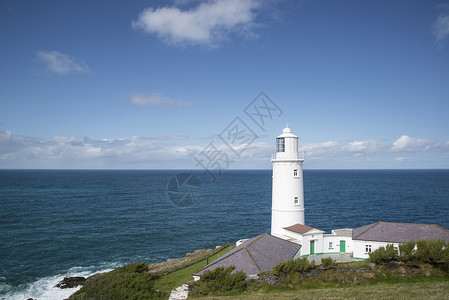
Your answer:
[0,0,449,171]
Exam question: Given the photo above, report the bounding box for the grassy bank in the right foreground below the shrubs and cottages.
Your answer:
[189,261,449,300]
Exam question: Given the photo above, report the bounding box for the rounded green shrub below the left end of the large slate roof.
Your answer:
[193,266,246,295]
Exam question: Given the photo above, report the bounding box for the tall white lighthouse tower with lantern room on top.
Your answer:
[271,125,304,237]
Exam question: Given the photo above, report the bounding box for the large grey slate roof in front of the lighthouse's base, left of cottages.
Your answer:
[194,233,301,276]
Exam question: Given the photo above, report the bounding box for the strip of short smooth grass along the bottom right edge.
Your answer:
[195,280,449,300]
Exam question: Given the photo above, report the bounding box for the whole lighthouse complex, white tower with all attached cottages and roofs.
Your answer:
[194,127,449,280]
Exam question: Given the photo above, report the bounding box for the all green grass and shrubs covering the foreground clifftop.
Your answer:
[70,241,449,300]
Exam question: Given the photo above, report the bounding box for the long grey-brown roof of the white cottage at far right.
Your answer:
[352,221,449,243]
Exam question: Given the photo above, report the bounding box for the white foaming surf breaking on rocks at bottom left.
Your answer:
[0,263,122,300]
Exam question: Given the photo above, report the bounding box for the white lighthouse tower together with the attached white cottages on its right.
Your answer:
[271,127,449,259]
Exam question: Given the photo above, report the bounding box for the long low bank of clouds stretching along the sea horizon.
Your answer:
[0,129,449,169]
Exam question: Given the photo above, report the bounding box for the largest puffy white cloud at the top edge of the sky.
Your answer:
[132,0,261,46]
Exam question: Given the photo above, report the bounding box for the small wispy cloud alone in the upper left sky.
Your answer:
[37,51,90,75]
